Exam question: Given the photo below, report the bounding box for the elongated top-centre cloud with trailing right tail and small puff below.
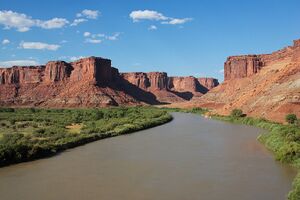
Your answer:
[129,10,192,26]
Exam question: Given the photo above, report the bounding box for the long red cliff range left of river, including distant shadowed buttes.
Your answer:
[0,57,219,107]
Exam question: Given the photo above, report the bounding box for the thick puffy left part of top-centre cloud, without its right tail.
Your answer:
[129,10,168,22]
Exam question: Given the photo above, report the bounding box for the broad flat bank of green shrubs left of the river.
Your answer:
[0,107,172,166]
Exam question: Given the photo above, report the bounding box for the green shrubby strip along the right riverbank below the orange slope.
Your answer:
[171,108,300,200]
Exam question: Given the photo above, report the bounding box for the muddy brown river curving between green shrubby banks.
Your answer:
[0,113,296,200]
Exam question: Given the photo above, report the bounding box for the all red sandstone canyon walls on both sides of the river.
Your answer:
[0,40,300,122]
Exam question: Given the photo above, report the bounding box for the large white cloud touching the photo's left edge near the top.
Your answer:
[0,10,69,32]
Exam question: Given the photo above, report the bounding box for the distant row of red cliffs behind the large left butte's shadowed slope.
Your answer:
[121,72,218,103]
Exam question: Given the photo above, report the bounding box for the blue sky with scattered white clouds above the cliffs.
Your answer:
[0,0,300,80]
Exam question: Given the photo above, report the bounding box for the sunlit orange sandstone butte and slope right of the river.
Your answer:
[172,40,300,122]
